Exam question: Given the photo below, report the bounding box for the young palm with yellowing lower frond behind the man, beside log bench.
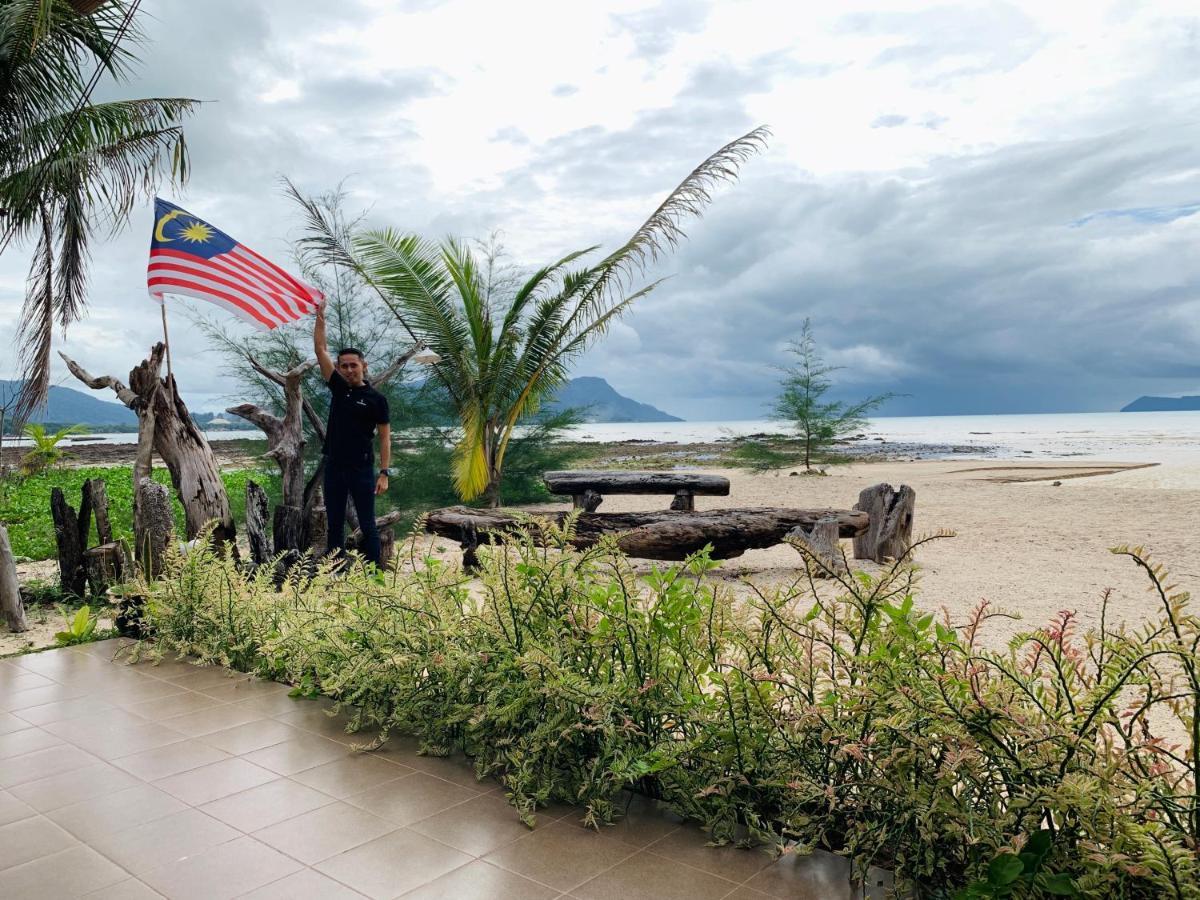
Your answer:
[292,128,769,506]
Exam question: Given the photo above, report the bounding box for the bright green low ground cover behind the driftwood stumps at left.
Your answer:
[0,466,280,559]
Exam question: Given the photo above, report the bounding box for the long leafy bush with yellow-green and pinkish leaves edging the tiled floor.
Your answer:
[138,532,1200,899]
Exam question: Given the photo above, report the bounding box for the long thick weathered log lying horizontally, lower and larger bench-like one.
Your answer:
[426,506,868,559]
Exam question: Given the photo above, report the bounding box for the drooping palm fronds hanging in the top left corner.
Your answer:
[0,0,197,419]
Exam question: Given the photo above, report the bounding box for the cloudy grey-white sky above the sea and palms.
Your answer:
[0,0,1200,420]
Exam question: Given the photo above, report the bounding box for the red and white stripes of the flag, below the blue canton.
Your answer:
[146,245,324,330]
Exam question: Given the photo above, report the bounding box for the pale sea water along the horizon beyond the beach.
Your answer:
[16,412,1200,463]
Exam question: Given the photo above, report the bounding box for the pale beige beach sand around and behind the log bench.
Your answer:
[511,460,1200,648]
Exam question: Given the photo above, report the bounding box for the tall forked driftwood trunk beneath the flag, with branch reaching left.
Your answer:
[59,343,236,544]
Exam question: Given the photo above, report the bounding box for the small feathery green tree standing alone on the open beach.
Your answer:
[770,319,895,470]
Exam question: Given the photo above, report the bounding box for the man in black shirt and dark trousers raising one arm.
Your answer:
[312,302,391,565]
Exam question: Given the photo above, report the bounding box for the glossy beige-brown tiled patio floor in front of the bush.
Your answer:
[0,641,875,900]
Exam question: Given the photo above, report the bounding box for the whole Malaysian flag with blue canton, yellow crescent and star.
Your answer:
[146,198,324,329]
